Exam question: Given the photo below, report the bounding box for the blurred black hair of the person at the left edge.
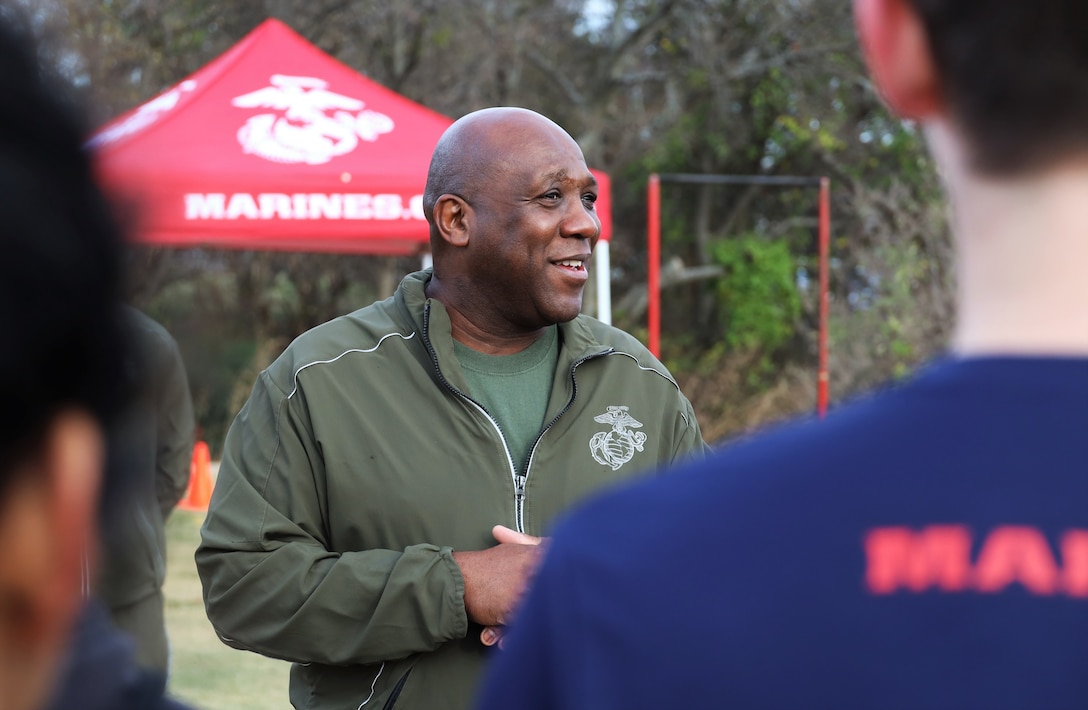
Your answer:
[0,8,126,496]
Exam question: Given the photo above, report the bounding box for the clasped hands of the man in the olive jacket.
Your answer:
[454,525,543,646]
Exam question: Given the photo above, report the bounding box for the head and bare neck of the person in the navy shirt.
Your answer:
[854,0,1088,356]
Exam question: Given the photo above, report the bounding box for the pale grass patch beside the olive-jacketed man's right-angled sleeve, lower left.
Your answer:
[165,510,290,710]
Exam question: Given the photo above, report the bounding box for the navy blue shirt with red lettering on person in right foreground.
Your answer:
[482,358,1088,710]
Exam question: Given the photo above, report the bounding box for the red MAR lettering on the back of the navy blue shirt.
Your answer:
[865,525,1088,598]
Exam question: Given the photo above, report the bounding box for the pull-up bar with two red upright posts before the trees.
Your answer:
[646,173,831,416]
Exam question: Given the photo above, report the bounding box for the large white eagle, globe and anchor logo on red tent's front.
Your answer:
[231,74,395,165]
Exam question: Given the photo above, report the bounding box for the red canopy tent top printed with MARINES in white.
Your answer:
[90,20,611,258]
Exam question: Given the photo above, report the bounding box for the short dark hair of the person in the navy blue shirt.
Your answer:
[911,0,1088,175]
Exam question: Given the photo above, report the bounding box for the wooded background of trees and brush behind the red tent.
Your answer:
[42,0,952,447]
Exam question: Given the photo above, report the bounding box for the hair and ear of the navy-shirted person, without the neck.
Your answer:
[854,0,1088,177]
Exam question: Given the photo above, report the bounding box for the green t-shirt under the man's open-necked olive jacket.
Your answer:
[454,326,559,473]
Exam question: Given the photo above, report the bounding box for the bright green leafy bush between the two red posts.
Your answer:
[713,234,801,379]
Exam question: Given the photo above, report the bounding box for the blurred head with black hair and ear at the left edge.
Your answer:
[0,5,124,710]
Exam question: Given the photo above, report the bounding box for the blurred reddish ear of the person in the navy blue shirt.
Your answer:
[854,0,943,120]
